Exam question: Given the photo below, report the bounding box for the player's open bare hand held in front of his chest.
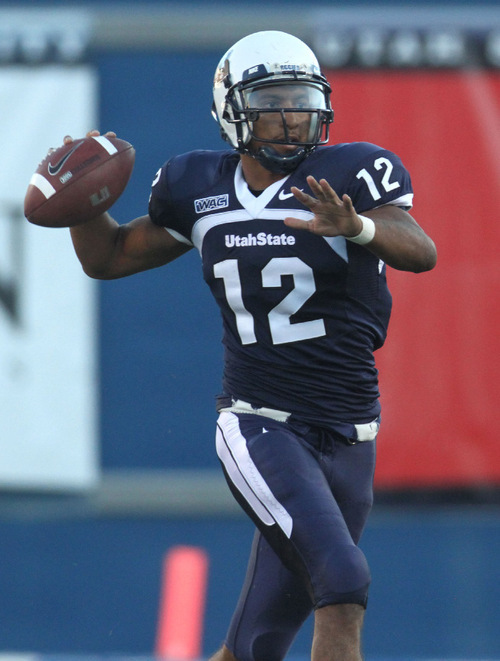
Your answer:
[284,176,363,237]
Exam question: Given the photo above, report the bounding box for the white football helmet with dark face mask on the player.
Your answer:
[212,31,333,173]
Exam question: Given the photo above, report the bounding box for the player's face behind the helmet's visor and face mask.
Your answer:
[245,84,325,152]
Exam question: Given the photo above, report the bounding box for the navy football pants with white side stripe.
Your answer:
[216,412,375,661]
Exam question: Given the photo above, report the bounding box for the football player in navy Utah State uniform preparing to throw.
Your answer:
[66,31,436,661]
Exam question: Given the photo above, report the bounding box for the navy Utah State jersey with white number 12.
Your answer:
[149,143,413,438]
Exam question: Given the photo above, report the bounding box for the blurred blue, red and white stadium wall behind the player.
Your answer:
[0,0,500,661]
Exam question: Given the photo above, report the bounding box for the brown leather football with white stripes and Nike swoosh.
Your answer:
[24,135,135,227]
